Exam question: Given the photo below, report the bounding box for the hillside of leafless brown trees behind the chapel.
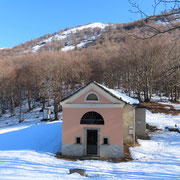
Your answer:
[0,15,180,119]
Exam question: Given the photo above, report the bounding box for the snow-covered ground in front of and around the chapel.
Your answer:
[0,102,180,180]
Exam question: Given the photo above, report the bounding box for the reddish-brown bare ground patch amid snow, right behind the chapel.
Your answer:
[142,102,180,116]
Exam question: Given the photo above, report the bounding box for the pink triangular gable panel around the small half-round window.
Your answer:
[71,89,112,104]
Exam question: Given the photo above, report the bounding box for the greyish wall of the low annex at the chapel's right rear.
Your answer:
[135,108,146,138]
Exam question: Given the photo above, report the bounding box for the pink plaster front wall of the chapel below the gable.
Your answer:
[62,107,123,145]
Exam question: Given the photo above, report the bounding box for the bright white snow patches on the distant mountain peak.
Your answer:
[32,23,108,52]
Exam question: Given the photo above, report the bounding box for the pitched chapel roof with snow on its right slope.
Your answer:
[61,81,139,105]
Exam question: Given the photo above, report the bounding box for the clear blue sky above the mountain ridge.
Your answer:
[0,0,166,48]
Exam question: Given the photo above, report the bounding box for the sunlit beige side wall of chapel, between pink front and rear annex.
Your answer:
[123,104,135,145]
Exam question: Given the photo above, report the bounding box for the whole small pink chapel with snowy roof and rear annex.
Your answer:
[60,82,146,158]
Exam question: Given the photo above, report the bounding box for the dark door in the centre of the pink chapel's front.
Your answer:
[87,130,98,155]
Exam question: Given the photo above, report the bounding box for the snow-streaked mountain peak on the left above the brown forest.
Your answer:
[0,23,109,58]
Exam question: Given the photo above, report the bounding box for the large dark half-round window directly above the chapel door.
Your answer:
[80,111,104,125]
